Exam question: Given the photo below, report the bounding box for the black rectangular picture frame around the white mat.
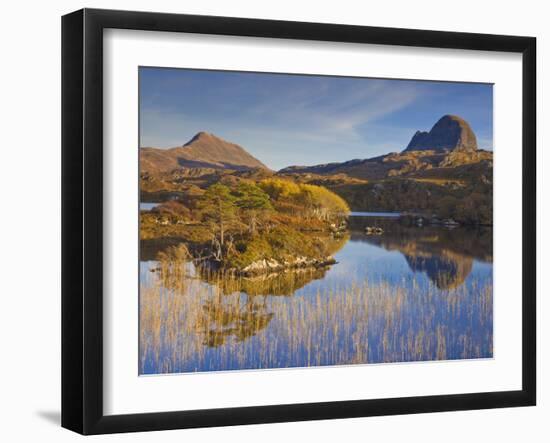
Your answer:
[62,9,536,434]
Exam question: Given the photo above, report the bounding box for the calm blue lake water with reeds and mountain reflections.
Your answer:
[140,213,493,374]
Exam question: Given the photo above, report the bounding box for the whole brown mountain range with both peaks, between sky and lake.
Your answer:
[140,116,493,225]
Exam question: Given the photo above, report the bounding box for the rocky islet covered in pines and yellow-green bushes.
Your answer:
[140,176,349,273]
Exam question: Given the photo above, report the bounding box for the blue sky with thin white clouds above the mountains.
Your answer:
[140,68,493,169]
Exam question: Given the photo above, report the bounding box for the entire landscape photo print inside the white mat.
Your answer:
[139,67,493,375]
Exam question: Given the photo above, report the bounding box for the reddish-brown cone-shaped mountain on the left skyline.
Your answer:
[140,132,268,173]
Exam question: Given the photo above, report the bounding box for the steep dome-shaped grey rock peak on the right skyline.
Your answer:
[404,115,477,152]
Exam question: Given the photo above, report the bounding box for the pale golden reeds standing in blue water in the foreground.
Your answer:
[140,268,493,374]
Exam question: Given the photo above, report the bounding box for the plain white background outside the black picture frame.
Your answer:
[0,0,550,443]
